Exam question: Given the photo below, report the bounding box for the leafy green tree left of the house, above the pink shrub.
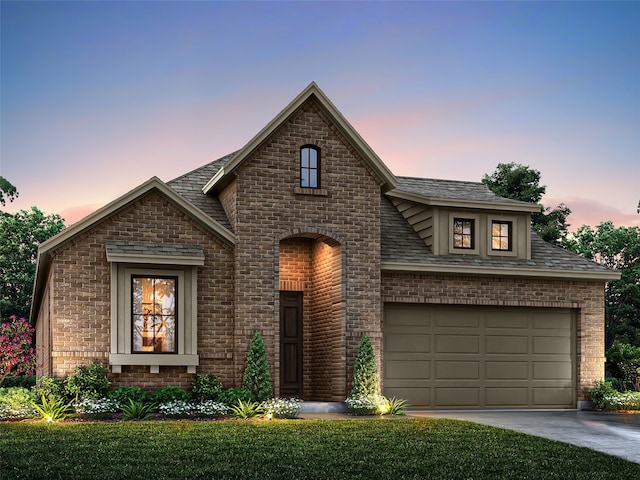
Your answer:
[0,207,64,318]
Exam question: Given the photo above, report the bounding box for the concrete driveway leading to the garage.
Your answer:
[407,410,640,463]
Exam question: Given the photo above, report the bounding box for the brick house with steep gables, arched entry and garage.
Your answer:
[31,83,618,409]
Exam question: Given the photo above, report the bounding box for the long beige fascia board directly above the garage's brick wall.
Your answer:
[380,262,621,282]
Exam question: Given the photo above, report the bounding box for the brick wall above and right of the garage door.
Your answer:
[382,273,605,400]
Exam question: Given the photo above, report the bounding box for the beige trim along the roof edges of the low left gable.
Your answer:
[30,177,235,318]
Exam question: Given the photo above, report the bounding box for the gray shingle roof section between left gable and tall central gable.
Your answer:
[167,152,235,230]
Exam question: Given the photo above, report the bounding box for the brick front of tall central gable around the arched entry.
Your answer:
[228,97,381,393]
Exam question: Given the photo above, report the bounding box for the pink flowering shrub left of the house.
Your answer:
[0,315,36,384]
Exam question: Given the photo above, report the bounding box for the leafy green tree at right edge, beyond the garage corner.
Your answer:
[569,222,640,349]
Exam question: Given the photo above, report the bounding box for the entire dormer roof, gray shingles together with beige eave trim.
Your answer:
[387,177,542,212]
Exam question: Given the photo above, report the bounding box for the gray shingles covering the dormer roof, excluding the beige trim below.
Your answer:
[396,177,528,205]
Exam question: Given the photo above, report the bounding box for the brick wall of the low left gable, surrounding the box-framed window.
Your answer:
[45,193,236,389]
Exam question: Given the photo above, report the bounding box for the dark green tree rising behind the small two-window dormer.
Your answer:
[482,163,571,246]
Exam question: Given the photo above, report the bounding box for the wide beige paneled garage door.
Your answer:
[383,304,576,409]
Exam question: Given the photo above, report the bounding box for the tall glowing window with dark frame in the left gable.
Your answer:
[131,275,178,353]
